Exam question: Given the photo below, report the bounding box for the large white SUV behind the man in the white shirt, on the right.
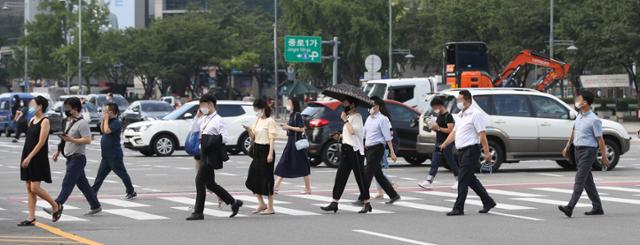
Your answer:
[417,88,631,171]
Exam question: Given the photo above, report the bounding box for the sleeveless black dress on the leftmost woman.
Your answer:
[20,117,51,183]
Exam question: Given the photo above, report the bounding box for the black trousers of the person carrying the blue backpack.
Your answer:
[194,162,236,214]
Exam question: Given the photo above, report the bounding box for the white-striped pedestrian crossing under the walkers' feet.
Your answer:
[7,186,640,222]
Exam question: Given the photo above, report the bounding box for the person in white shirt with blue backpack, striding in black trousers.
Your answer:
[187,94,242,220]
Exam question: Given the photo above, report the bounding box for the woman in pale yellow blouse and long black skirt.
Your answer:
[244,99,278,215]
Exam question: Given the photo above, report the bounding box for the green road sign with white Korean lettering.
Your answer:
[284,36,322,63]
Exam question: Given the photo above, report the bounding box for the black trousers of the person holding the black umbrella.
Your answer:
[333,144,369,200]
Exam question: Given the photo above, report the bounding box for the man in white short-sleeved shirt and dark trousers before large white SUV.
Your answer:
[440,90,496,216]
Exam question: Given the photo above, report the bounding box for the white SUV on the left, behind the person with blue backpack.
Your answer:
[124,100,256,156]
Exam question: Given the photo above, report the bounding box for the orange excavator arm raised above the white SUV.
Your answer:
[493,50,569,91]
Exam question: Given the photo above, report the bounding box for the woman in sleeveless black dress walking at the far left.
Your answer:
[18,96,60,226]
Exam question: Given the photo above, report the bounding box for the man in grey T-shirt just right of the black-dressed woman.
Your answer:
[44,97,102,217]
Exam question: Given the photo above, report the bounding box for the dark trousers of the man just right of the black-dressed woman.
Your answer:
[56,154,100,209]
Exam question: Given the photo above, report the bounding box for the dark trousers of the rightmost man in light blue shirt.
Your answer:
[569,146,602,209]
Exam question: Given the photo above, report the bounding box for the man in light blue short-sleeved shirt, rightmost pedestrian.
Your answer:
[558,90,609,217]
